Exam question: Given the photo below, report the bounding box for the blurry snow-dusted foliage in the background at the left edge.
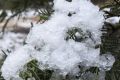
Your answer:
[0,32,26,55]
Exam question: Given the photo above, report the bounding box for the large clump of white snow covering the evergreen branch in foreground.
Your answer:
[2,0,115,80]
